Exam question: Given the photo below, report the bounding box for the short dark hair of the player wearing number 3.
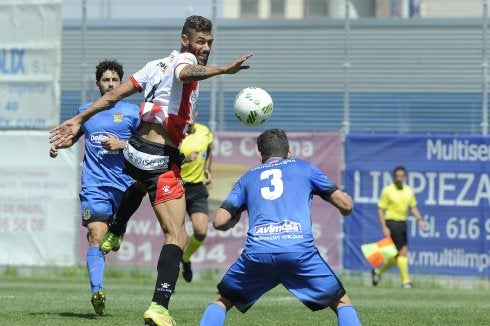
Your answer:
[257,129,289,162]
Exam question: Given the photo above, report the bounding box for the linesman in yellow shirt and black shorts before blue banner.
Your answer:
[371,166,425,289]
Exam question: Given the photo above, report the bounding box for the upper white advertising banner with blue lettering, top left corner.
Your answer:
[0,0,61,130]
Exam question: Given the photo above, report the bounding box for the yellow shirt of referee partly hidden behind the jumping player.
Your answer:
[180,123,213,183]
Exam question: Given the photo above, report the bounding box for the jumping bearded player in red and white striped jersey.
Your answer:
[50,16,252,326]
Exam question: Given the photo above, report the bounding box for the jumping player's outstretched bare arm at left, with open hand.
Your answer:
[49,80,138,146]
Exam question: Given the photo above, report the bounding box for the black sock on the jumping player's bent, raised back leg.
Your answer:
[109,183,146,236]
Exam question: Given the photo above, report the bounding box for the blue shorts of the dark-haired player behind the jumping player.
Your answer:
[80,187,124,226]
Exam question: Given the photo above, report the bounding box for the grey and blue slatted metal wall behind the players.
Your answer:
[61,1,488,135]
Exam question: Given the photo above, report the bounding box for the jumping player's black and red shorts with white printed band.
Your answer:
[123,135,184,205]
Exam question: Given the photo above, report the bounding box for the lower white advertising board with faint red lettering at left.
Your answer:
[0,130,80,266]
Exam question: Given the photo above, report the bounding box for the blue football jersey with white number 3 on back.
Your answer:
[221,158,338,253]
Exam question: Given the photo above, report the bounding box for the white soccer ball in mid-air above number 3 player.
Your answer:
[234,87,272,126]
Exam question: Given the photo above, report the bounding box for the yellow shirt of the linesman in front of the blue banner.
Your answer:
[378,184,417,221]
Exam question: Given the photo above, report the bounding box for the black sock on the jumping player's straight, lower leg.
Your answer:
[152,244,183,309]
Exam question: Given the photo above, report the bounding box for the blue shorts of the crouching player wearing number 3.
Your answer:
[218,250,345,313]
